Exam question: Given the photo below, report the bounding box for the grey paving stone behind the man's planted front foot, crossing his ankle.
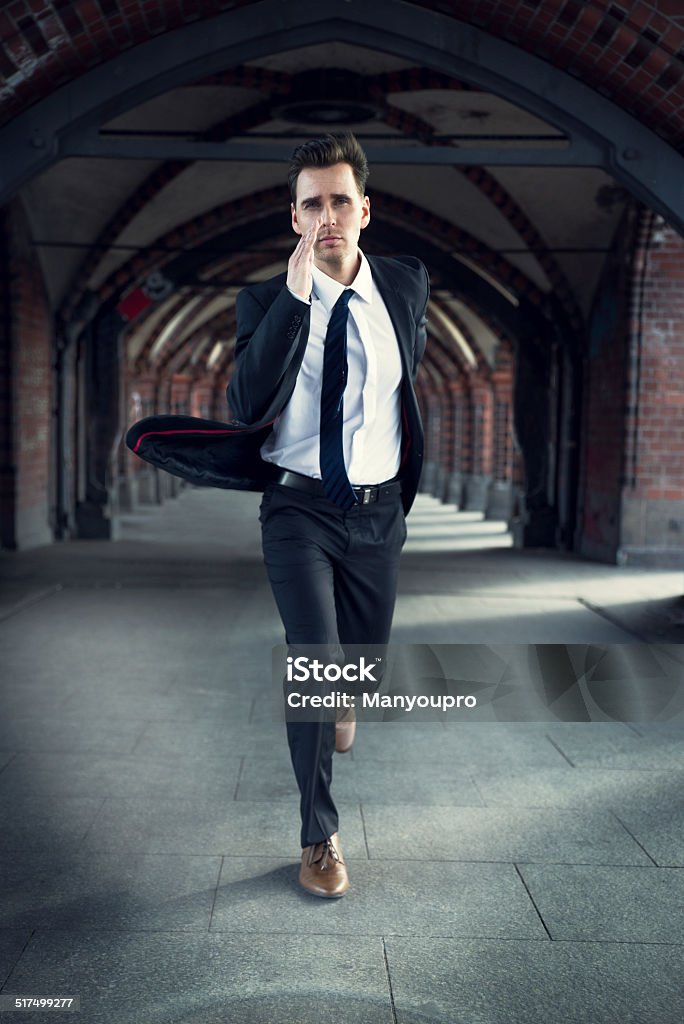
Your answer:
[84,798,367,860]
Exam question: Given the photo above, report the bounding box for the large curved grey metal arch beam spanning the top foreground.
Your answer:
[0,0,684,234]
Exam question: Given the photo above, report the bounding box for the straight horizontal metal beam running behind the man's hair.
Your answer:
[57,131,605,167]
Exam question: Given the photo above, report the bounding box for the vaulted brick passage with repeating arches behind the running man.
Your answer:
[0,2,684,565]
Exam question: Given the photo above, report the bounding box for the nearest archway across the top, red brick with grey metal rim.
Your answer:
[0,0,684,231]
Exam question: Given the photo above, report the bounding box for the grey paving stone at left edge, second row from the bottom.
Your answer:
[3,852,220,932]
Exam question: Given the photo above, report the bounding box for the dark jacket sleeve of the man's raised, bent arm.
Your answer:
[226,285,310,425]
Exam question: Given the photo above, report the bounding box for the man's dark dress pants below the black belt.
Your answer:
[259,483,407,847]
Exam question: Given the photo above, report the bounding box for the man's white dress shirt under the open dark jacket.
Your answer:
[261,250,401,485]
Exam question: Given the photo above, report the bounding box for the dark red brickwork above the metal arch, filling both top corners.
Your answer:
[0,0,684,147]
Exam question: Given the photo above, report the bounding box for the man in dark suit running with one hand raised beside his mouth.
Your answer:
[126,133,429,897]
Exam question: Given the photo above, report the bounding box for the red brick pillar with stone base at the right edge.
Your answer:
[576,205,684,566]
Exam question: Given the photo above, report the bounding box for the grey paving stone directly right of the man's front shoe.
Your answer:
[364,804,652,864]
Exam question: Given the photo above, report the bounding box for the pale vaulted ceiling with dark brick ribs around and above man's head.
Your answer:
[14,44,627,376]
